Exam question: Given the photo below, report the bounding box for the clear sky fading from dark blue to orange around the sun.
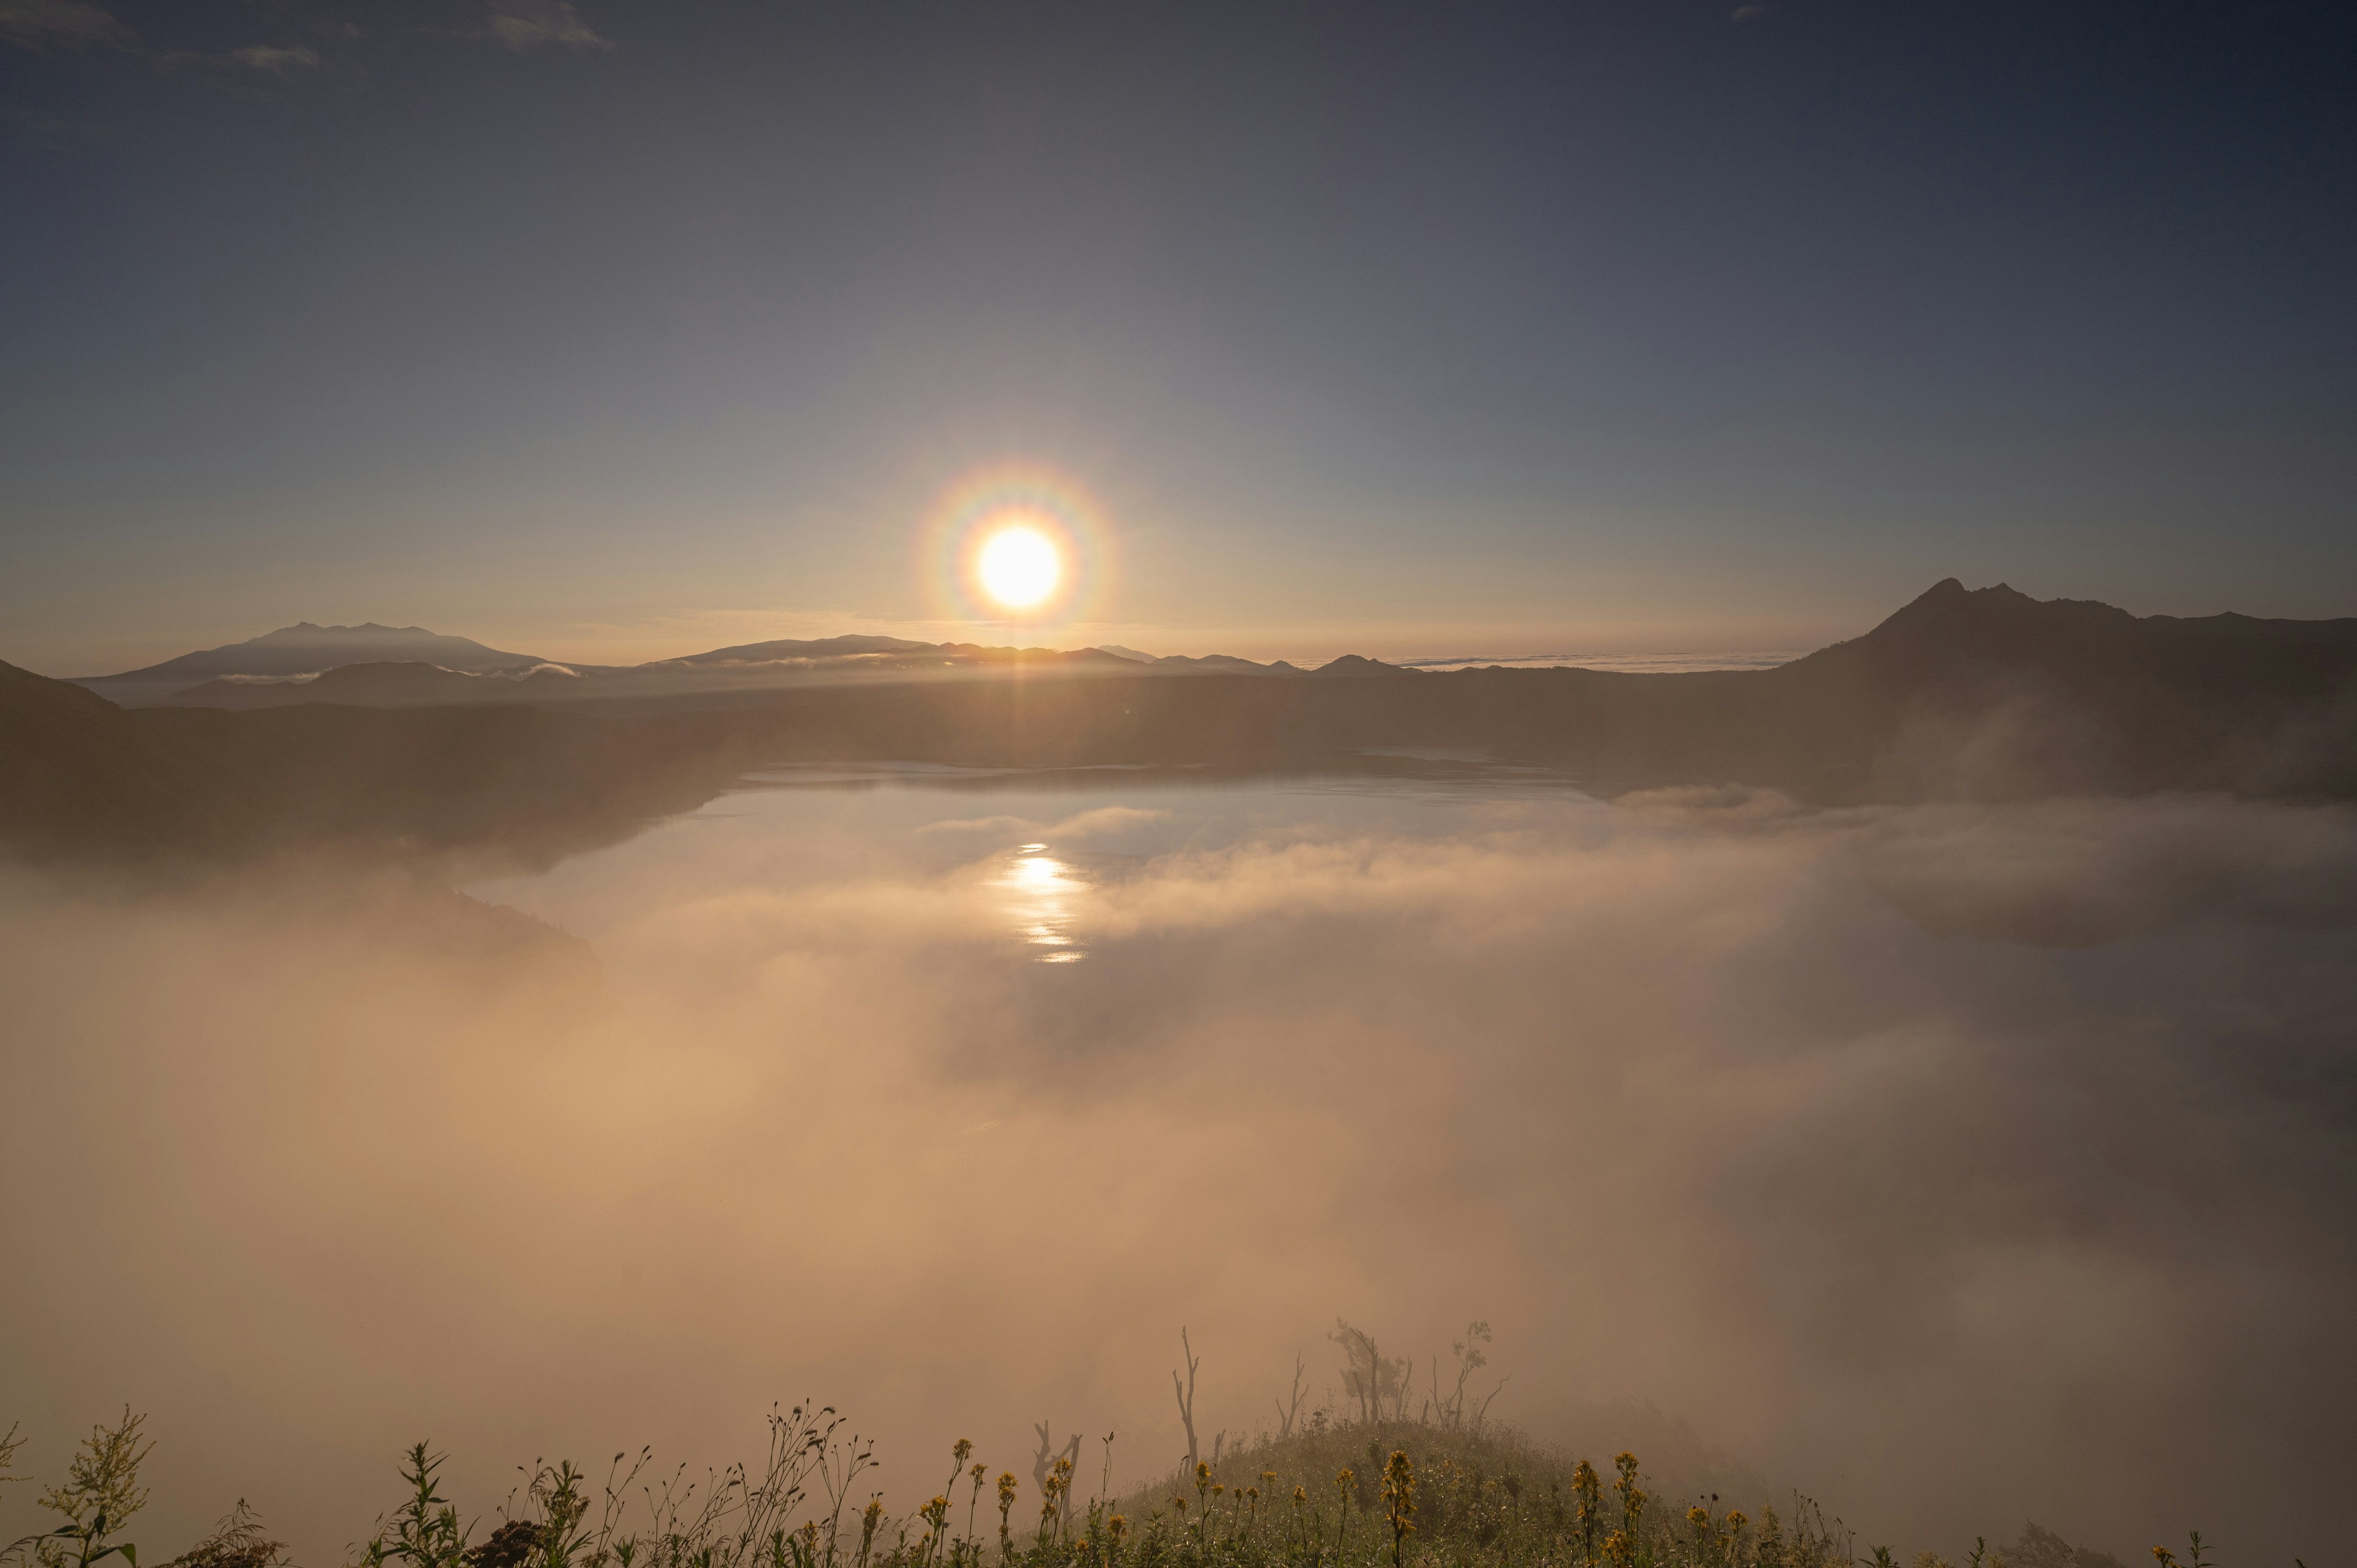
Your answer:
[0,0,2357,674]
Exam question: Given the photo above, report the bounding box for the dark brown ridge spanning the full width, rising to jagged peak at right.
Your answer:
[0,580,2357,860]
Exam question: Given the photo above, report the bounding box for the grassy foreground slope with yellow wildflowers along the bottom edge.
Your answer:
[0,1405,2208,1568]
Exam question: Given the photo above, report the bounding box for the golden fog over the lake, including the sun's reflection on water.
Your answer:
[0,754,2357,1566]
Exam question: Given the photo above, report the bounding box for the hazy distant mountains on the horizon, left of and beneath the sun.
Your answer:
[73,620,1395,709]
